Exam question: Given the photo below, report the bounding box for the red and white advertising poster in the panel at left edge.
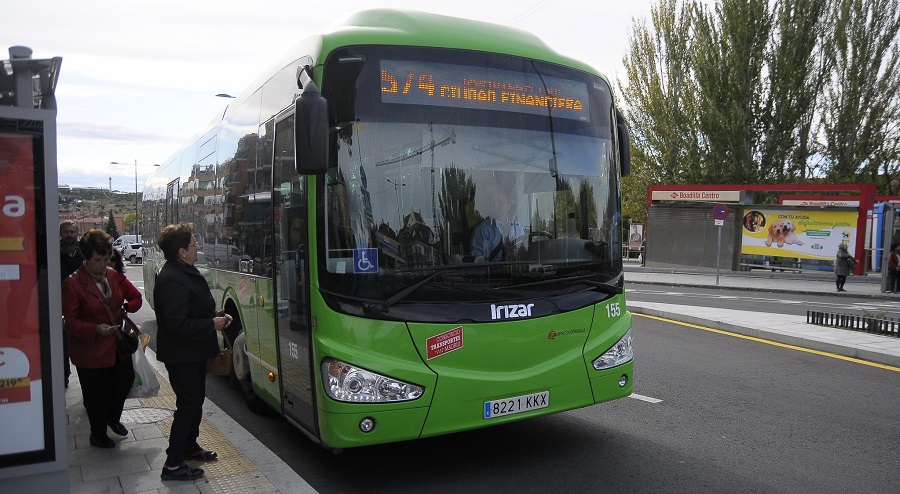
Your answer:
[0,132,45,455]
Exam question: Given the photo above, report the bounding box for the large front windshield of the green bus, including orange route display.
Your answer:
[318,46,622,316]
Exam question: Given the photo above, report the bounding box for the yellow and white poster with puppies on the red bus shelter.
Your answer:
[741,208,859,261]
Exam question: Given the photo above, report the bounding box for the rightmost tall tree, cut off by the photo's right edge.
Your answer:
[821,0,900,194]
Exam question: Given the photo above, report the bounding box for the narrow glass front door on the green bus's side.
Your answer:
[273,113,318,437]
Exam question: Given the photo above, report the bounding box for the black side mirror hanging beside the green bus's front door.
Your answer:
[294,81,328,175]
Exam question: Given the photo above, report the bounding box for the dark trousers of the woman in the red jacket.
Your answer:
[75,358,134,437]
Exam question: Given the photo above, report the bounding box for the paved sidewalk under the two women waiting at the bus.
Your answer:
[66,348,316,494]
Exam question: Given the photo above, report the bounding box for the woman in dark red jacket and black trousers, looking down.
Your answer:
[62,230,143,448]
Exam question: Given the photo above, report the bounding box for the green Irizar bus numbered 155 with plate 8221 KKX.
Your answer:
[141,10,633,450]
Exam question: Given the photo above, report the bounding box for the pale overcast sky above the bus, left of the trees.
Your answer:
[0,0,656,191]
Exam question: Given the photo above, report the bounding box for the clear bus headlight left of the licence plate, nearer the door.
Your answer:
[322,359,425,403]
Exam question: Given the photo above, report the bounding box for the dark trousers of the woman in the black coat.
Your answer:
[166,361,206,467]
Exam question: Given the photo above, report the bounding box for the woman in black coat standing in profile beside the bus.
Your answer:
[153,223,232,480]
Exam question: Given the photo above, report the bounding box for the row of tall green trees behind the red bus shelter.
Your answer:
[618,0,900,222]
